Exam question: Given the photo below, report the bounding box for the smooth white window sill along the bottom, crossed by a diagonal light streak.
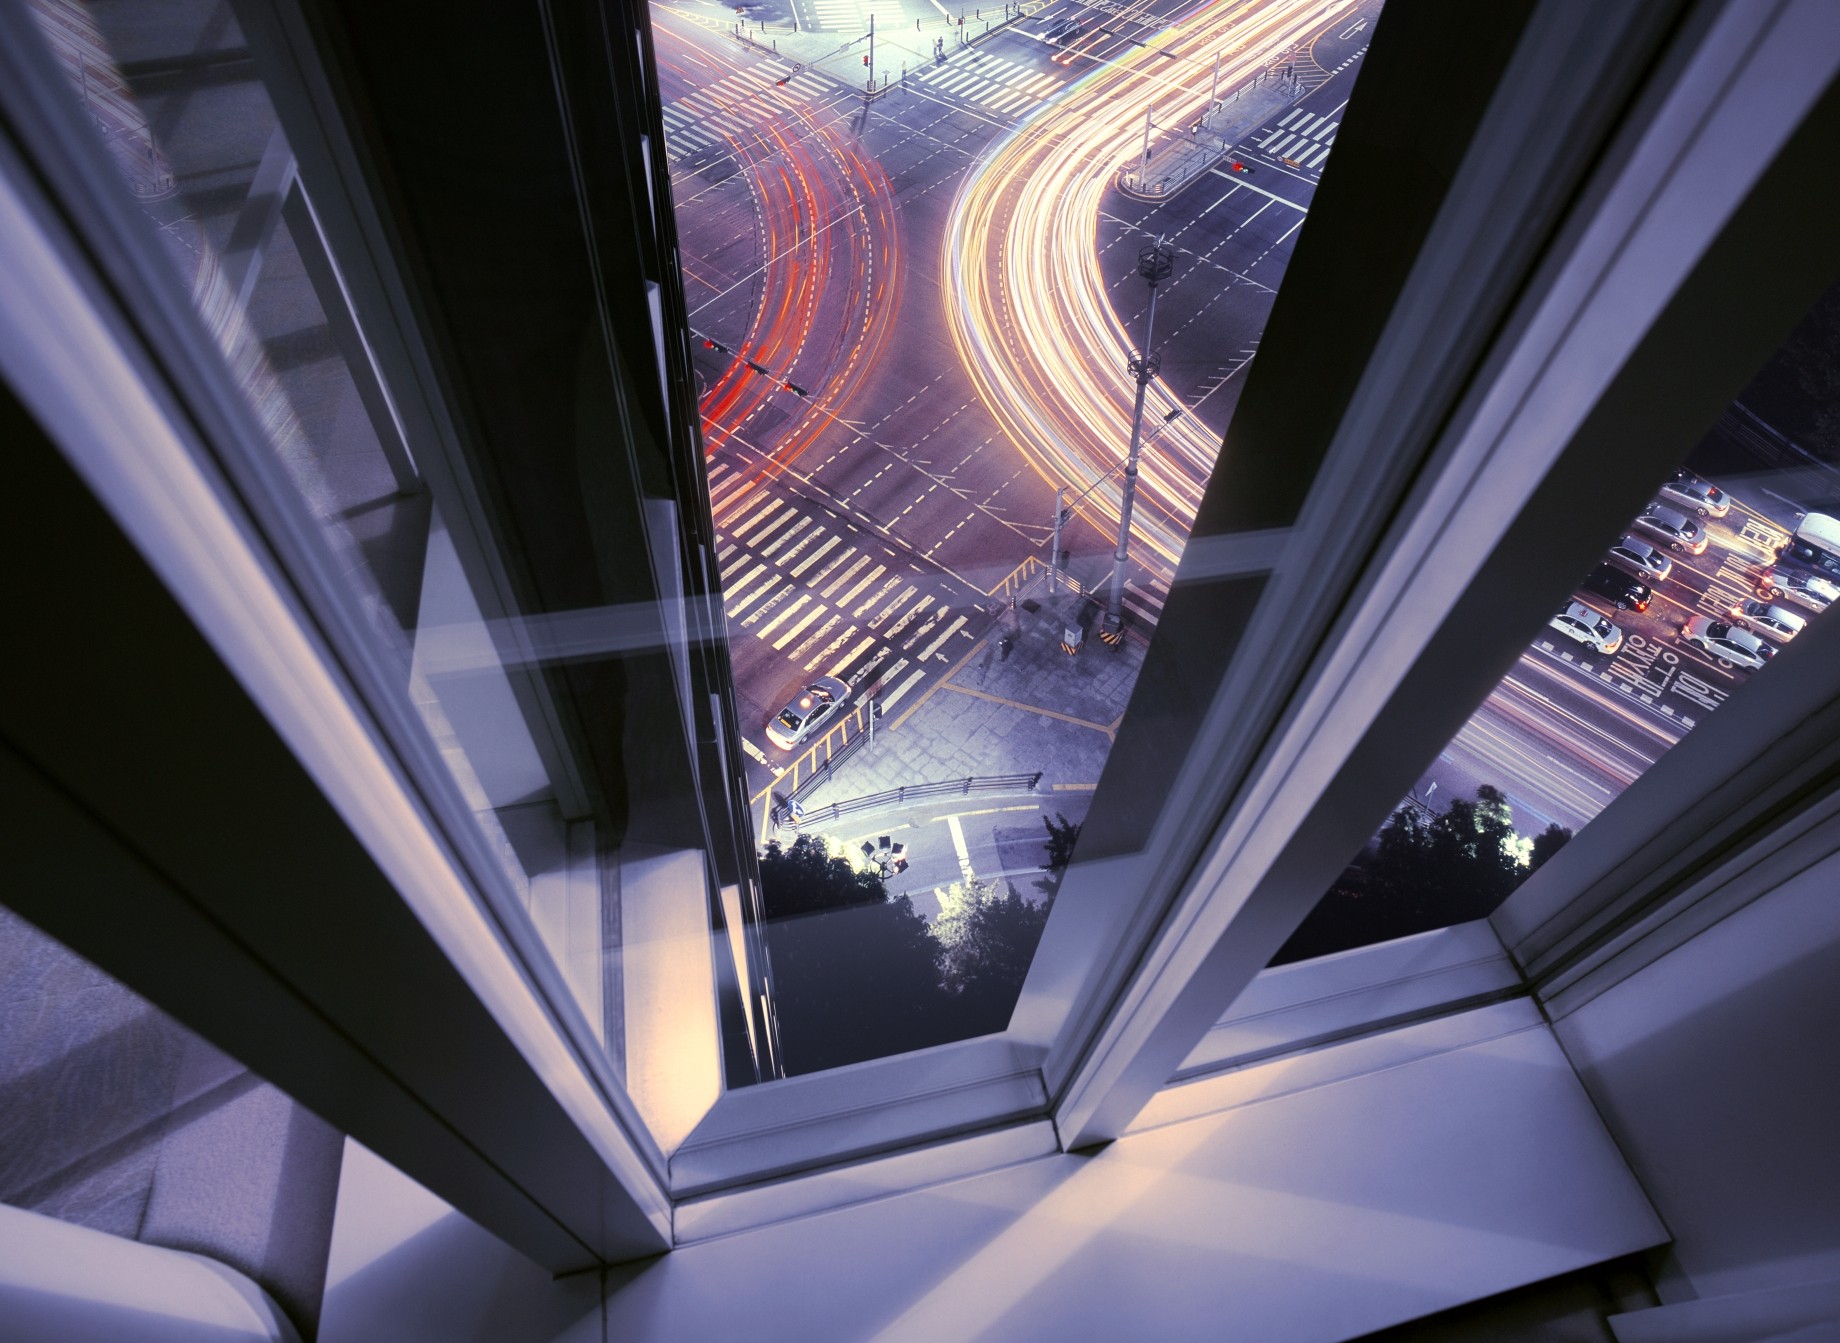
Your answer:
[320,1001,1665,1343]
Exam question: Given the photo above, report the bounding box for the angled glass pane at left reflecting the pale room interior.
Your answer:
[21,0,739,1144]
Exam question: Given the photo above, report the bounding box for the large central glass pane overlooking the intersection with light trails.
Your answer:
[653,0,1378,1073]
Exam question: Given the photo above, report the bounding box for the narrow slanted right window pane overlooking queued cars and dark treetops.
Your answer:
[1273,287,1840,964]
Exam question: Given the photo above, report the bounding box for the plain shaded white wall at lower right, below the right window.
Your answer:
[1558,842,1840,1299]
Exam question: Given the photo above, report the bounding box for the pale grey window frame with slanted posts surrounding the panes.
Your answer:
[0,0,1840,1268]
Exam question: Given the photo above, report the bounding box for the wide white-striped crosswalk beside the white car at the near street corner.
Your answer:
[708,462,983,710]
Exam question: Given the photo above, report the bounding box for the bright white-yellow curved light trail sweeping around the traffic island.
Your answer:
[942,0,1349,565]
